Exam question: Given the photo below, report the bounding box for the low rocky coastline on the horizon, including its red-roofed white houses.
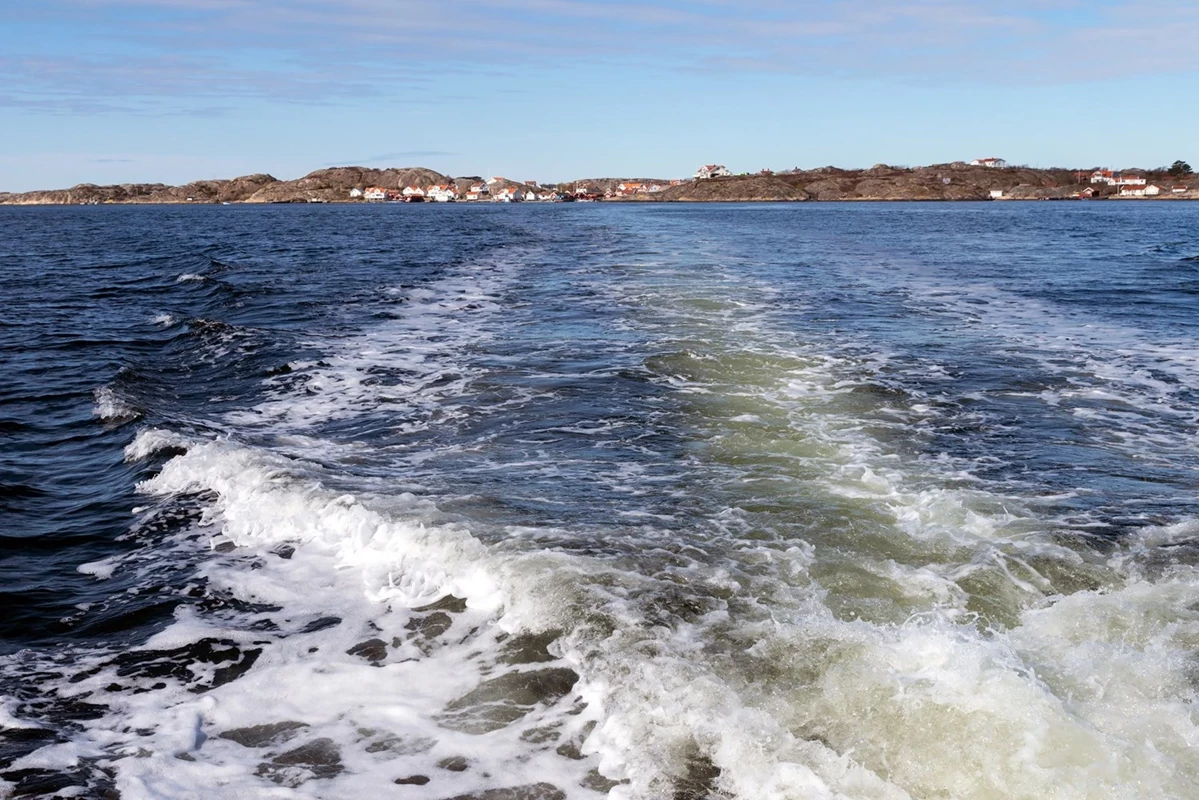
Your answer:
[0,162,1199,205]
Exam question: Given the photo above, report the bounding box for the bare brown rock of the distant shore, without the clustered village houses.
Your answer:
[0,162,1199,205]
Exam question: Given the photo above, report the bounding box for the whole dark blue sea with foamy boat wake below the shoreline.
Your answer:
[0,201,1199,800]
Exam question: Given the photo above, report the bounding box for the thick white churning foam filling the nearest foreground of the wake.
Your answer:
[14,434,1199,800]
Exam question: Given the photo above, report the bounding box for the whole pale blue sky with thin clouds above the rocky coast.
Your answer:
[0,0,1199,192]
